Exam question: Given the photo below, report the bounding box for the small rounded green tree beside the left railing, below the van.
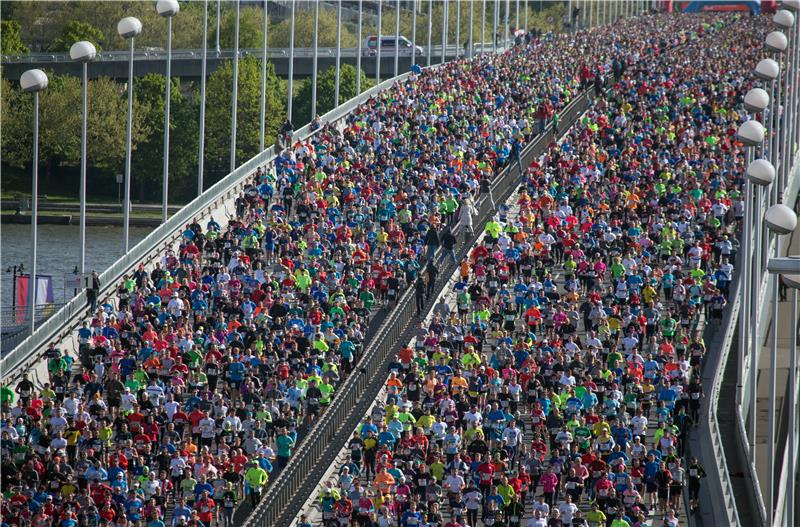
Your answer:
[293,64,372,125]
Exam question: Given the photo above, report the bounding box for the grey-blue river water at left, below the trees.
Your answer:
[0,225,151,308]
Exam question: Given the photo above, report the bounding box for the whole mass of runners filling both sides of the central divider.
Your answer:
[0,7,755,527]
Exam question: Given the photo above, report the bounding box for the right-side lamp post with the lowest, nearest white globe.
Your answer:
[764,203,797,525]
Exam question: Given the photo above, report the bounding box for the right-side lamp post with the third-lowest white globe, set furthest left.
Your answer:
[736,119,769,459]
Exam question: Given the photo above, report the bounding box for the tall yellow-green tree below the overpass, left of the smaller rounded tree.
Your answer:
[206,58,286,177]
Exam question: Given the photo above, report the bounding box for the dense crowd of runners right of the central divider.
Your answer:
[299,10,765,527]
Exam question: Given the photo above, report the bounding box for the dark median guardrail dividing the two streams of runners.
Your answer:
[245,86,589,527]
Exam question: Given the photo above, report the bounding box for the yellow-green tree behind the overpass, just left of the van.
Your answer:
[269,6,356,48]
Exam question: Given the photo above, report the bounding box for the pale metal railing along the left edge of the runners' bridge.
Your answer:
[0,69,409,383]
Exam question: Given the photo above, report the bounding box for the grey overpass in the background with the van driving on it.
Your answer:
[2,44,482,81]
